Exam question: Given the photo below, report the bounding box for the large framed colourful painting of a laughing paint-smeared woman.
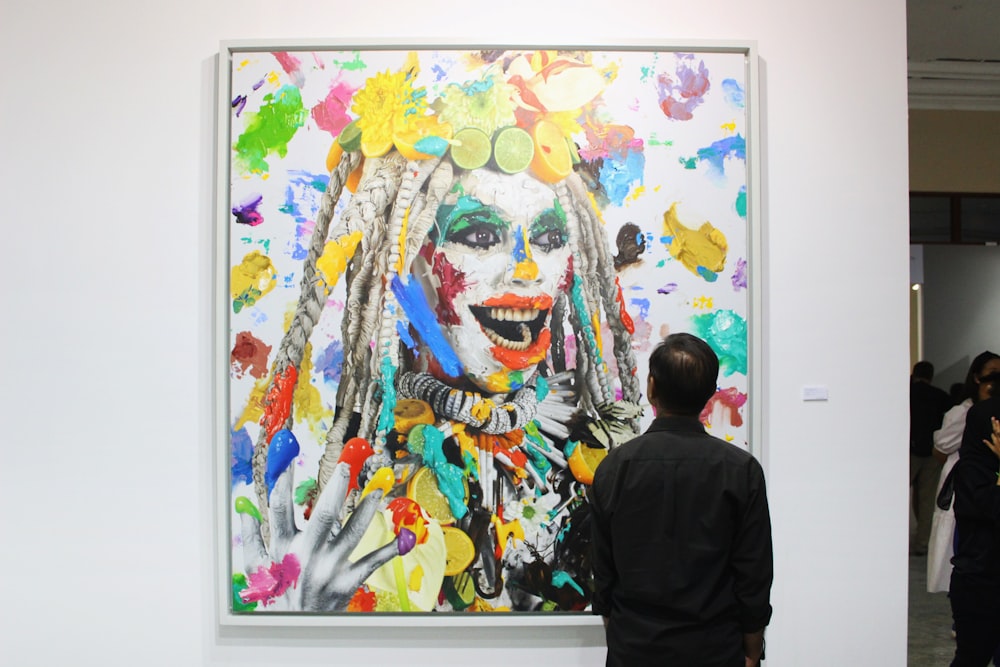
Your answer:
[216,42,760,624]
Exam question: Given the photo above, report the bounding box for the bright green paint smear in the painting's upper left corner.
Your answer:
[233,85,307,174]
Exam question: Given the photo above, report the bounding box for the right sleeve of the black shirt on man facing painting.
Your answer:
[731,459,774,633]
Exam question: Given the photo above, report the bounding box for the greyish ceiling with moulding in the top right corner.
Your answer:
[906,0,1000,111]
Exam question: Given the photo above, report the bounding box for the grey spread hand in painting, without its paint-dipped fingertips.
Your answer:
[237,464,413,612]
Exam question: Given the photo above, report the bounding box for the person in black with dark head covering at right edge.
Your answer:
[950,373,1000,667]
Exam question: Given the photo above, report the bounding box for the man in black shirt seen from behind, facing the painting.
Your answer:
[591,334,773,667]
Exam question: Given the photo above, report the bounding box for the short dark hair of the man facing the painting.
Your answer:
[649,333,719,415]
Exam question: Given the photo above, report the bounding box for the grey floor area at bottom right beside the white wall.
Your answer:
[906,556,955,667]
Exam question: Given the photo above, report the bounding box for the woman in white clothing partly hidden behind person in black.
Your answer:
[927,351,1000,593]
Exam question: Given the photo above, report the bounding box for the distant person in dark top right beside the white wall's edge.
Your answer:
[910,361,952,556]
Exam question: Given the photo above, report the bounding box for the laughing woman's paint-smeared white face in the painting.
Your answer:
[413,170,573,393]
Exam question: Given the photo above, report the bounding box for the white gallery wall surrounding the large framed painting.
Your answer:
[0,0,909,667]
